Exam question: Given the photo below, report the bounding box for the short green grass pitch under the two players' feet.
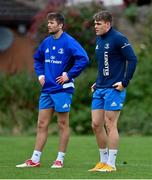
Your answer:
[0,136,152,179]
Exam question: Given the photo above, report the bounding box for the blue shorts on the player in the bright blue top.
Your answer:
[39,92,72,112]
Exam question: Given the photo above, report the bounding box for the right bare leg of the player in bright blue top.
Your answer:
[57,112,70,152]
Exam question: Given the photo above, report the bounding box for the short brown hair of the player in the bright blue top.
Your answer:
[47,12,65,26]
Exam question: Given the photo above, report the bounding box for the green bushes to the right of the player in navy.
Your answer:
[120,26,152,135]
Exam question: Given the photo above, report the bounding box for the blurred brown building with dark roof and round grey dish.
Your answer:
[0,0,38,73]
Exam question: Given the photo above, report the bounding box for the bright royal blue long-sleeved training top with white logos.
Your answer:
[34,32,89,93]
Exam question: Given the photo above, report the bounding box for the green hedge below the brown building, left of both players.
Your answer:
[0,72,40,134]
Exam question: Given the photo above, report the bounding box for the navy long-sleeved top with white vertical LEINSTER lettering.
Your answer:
[96,28,137,88]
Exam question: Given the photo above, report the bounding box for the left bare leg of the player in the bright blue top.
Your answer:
[35,109,54,152]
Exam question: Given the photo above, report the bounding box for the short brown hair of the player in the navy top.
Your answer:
[93,11,112,24]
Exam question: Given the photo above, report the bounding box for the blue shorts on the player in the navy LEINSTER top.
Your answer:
[92,88,126,111]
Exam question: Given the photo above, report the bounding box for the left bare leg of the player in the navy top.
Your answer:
[92,109,107,149]
